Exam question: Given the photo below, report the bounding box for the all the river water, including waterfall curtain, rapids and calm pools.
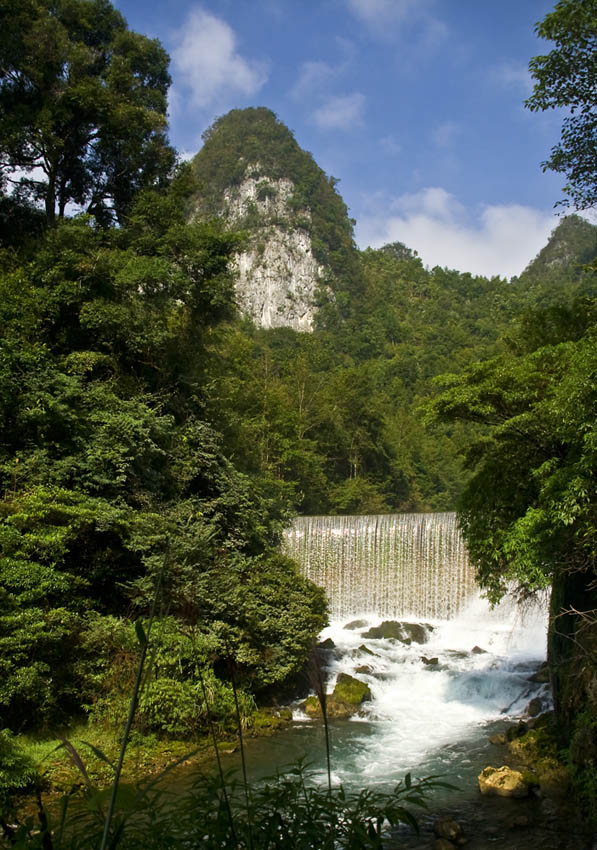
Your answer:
[234,514,597,850]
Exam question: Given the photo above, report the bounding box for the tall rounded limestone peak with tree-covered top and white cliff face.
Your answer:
[190,107,359,331]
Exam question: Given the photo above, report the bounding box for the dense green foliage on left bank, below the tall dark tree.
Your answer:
[0,164,325,735]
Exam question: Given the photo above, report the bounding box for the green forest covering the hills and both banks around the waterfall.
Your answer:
[0,0,597,828]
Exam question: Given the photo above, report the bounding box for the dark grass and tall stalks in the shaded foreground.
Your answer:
[0,579,445,850]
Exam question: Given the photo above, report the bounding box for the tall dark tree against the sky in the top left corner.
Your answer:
[0,0,175,224]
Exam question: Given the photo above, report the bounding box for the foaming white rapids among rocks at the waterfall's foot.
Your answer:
[304,598,549,785]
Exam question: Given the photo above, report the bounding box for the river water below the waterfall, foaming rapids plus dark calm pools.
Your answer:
[227,596,597,850]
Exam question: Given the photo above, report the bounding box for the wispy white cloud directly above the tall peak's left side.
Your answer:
[171,7,267,111]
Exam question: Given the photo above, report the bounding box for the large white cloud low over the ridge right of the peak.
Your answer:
[356,187,558,277]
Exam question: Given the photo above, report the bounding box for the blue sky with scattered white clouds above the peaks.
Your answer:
[115,0,563,277]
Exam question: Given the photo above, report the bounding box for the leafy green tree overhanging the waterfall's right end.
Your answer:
[430,299,597,765]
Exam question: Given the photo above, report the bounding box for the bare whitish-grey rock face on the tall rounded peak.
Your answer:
[222,169,324,331]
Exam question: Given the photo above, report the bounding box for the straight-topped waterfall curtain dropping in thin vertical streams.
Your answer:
[283,513,478,620]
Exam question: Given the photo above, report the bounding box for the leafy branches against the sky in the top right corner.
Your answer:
[526,0,597,209]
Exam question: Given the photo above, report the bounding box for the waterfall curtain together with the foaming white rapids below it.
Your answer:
[274,513,549,787]
